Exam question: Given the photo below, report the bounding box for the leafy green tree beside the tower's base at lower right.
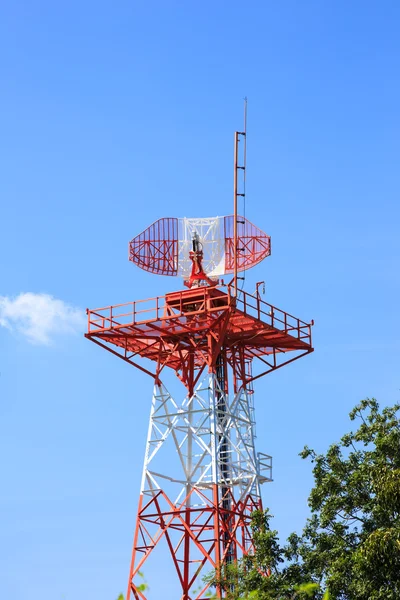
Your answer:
[208,399,400,600]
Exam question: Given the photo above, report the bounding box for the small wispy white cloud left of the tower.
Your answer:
[0,292,85,345]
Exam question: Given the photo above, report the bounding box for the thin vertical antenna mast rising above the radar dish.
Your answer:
[233,98,247,297]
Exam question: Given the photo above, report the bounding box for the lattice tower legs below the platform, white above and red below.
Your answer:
[127,374,272,600]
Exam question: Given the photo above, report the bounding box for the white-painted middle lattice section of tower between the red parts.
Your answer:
[142,374,272,506]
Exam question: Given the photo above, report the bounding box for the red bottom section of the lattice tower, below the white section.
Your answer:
[127,486,262,600]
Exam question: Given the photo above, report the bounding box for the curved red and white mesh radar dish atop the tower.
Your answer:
[129,215,271,279]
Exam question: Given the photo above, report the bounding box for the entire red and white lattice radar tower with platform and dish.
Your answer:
[86,123,312,600]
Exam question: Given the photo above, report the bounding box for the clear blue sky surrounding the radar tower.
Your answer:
[0,0,400,600]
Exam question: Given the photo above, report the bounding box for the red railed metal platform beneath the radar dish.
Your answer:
[85,286,313,384]
